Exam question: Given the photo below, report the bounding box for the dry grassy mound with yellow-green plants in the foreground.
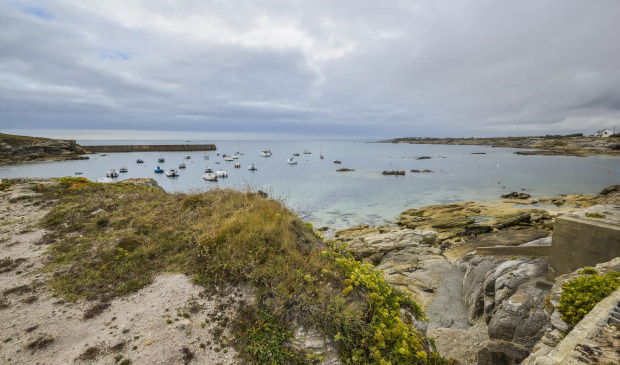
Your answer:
[37,178,447,364]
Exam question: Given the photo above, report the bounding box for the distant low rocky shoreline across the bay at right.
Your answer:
[381,136,620,157]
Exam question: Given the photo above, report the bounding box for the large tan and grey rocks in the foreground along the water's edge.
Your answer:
[334,186,620,364]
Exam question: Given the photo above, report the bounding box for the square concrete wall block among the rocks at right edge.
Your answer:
[550,216,620,276]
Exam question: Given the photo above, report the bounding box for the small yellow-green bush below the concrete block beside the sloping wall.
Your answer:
[557,268,620,327]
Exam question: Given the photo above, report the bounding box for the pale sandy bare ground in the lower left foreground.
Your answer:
[0,182,250,365]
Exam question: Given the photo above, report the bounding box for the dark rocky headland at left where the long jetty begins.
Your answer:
[0,133,89,165]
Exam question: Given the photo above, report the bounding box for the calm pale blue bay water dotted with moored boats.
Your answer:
[0,141,620,228]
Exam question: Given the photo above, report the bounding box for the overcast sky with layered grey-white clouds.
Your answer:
[0,0,620,139]
